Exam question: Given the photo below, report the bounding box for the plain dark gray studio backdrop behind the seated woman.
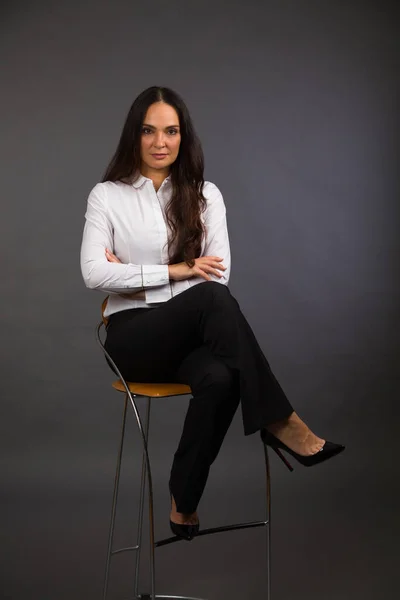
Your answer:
[0,0,400,600]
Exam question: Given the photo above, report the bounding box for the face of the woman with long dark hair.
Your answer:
[140,102,181,172]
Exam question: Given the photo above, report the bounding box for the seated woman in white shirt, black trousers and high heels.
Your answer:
[81,87,344,539]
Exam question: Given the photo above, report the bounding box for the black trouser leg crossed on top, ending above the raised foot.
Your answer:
[107,282,293,435]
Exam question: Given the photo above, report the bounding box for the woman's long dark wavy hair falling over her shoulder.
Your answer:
[102,86,206,267]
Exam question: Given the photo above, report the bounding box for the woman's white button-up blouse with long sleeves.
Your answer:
[81,175,231,317]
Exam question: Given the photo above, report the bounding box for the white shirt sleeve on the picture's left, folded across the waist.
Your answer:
[80,184,169,294]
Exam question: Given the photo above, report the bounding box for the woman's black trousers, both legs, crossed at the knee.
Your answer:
[105,281,293,513]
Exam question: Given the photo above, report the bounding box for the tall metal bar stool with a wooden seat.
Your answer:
[96,297,271,600]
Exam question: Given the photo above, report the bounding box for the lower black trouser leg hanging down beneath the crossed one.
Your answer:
[170,346,240,513]
